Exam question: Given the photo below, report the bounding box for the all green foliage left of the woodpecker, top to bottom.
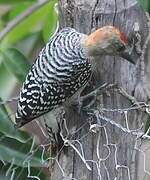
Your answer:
[0,0,58,180]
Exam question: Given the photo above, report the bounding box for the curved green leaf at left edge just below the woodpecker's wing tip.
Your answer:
[0,98,30,143]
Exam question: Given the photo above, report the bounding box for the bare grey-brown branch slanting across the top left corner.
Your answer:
[0,0,50,41]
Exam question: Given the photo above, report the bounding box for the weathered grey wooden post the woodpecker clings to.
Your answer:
[51,0,150,180]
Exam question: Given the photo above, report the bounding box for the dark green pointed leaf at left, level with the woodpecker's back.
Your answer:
[2,48,30,83]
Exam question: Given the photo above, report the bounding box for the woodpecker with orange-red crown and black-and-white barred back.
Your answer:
[15,26,134,128]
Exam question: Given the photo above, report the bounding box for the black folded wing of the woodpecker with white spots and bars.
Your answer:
[16,58,91,127]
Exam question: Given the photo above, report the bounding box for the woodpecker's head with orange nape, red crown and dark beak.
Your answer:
[84,26,135,63]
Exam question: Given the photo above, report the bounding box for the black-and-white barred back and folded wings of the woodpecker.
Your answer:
[16,28,91,127]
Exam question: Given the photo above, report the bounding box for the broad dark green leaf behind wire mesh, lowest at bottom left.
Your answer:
[0,135,47,167]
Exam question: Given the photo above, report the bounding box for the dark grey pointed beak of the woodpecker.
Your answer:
[120,47,138,64]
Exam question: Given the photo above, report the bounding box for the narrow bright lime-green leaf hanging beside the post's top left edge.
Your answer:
[43,0,58,42]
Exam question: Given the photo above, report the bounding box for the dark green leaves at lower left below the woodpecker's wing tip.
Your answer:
[0,100,47,179]
